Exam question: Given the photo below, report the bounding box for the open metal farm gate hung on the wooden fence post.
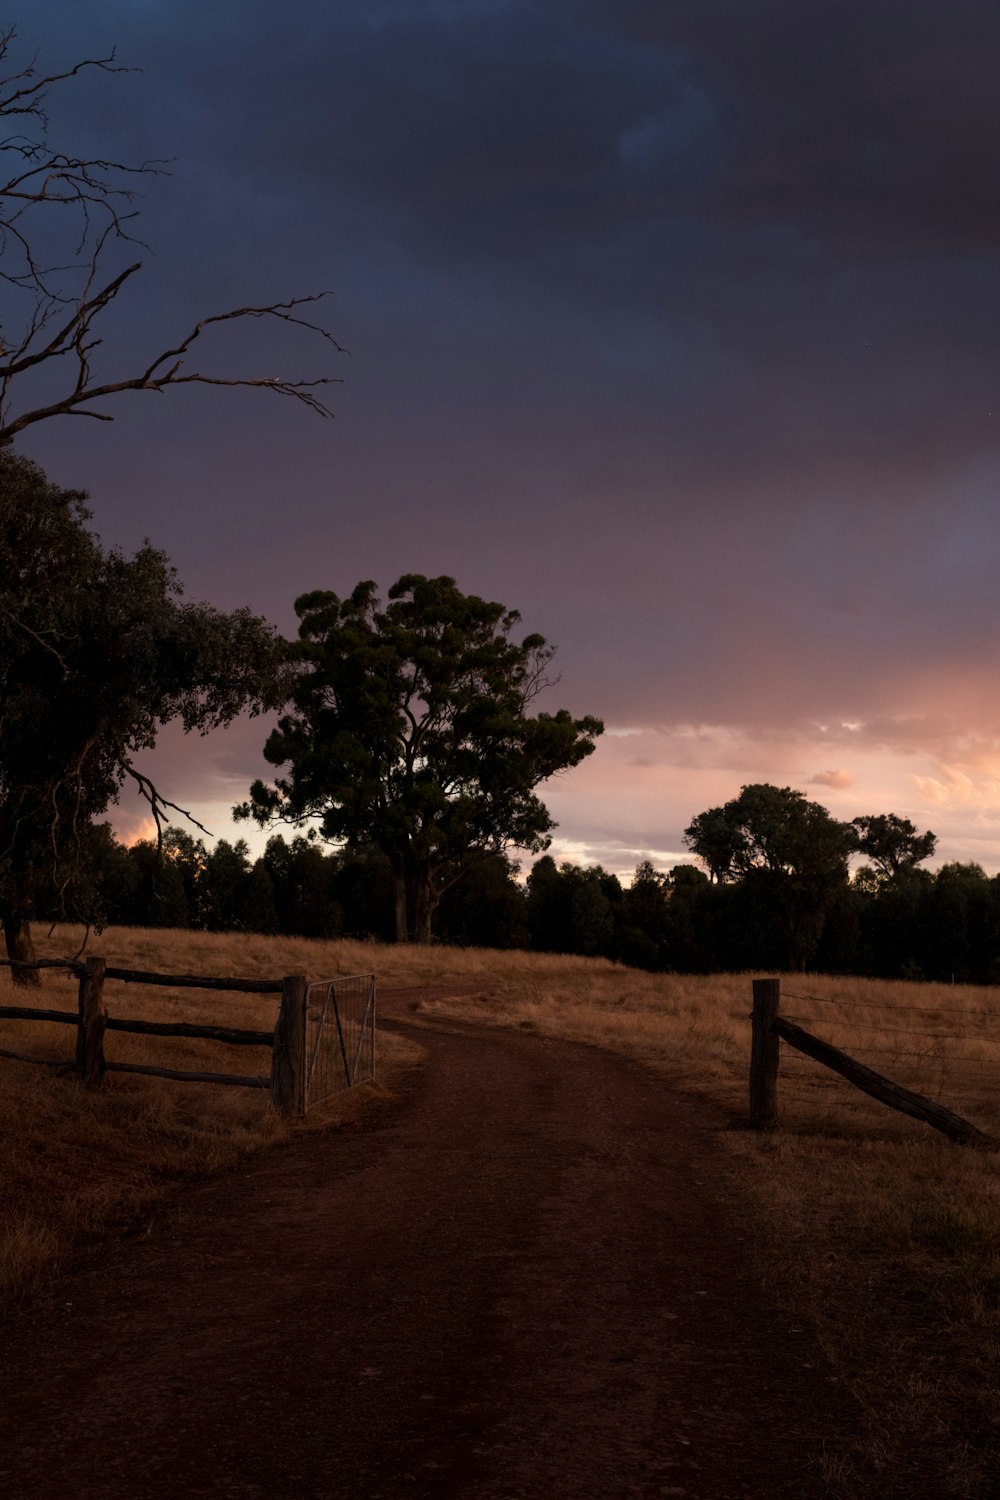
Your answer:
[306,974,375,1109]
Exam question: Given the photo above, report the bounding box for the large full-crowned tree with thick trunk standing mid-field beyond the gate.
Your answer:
[235,573,603,942]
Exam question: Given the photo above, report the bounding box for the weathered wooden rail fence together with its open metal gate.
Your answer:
[0,957,375,1116]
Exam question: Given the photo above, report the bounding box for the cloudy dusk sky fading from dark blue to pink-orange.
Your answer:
[15,0,1000,876]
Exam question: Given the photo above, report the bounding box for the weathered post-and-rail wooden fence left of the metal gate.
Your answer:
[0,957,373,1118]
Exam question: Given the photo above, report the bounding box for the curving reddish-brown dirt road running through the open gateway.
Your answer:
[0,998,886,1500]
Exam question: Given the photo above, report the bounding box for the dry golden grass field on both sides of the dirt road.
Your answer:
[0,929,1000,1500]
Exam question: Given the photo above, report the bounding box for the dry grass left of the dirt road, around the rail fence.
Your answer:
[0,929,420,1310]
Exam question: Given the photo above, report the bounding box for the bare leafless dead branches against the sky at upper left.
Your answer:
[0,27,345,446]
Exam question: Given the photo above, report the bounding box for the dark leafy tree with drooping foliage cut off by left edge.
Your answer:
[0,449,282,983]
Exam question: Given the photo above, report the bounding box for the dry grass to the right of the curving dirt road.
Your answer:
[374,950,1000,1500]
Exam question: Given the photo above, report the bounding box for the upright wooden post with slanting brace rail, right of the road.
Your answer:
[750,980,1000,1146]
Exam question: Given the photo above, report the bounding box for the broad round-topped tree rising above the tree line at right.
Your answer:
[684,783,855,969]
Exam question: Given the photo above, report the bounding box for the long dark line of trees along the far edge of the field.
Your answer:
[39,786,1000,984]
